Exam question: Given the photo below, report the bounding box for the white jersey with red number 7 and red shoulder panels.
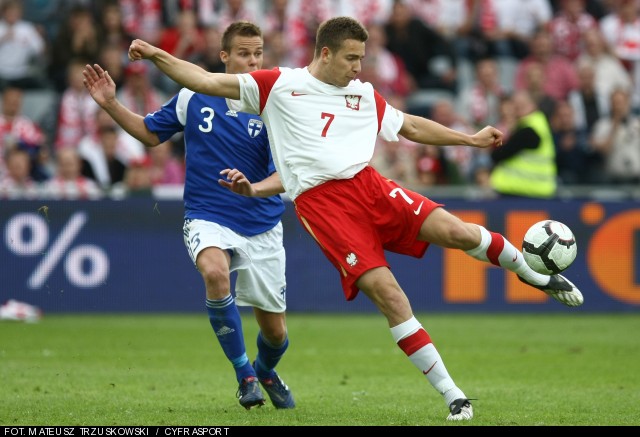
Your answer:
[238,67,404,200]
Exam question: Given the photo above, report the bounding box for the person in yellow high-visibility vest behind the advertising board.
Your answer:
[490,91,557,198]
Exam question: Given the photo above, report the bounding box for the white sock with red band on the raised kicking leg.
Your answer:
[466,225,550,285]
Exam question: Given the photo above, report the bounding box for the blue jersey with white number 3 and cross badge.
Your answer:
[144,88,284,236]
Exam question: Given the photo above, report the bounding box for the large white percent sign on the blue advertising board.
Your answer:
[5,212,109,290]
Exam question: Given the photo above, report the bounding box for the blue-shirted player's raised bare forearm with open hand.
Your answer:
[82,64,160,147]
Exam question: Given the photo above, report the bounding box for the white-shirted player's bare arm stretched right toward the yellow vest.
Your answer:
[399,113,503,148]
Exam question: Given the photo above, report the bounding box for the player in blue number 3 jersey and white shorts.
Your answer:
[83,22,295,409]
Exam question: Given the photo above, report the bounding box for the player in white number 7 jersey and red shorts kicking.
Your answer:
[129,17,583,420]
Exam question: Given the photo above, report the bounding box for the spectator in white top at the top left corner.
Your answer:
[0,0,45,89]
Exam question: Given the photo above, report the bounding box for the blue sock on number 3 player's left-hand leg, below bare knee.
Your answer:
[207,295,256,382]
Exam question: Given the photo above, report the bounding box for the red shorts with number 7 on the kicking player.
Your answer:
[294,167,443,300]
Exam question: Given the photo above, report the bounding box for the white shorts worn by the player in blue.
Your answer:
[183,220,287,313]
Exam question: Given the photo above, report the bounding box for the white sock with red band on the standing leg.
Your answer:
[391,317,466,406]
